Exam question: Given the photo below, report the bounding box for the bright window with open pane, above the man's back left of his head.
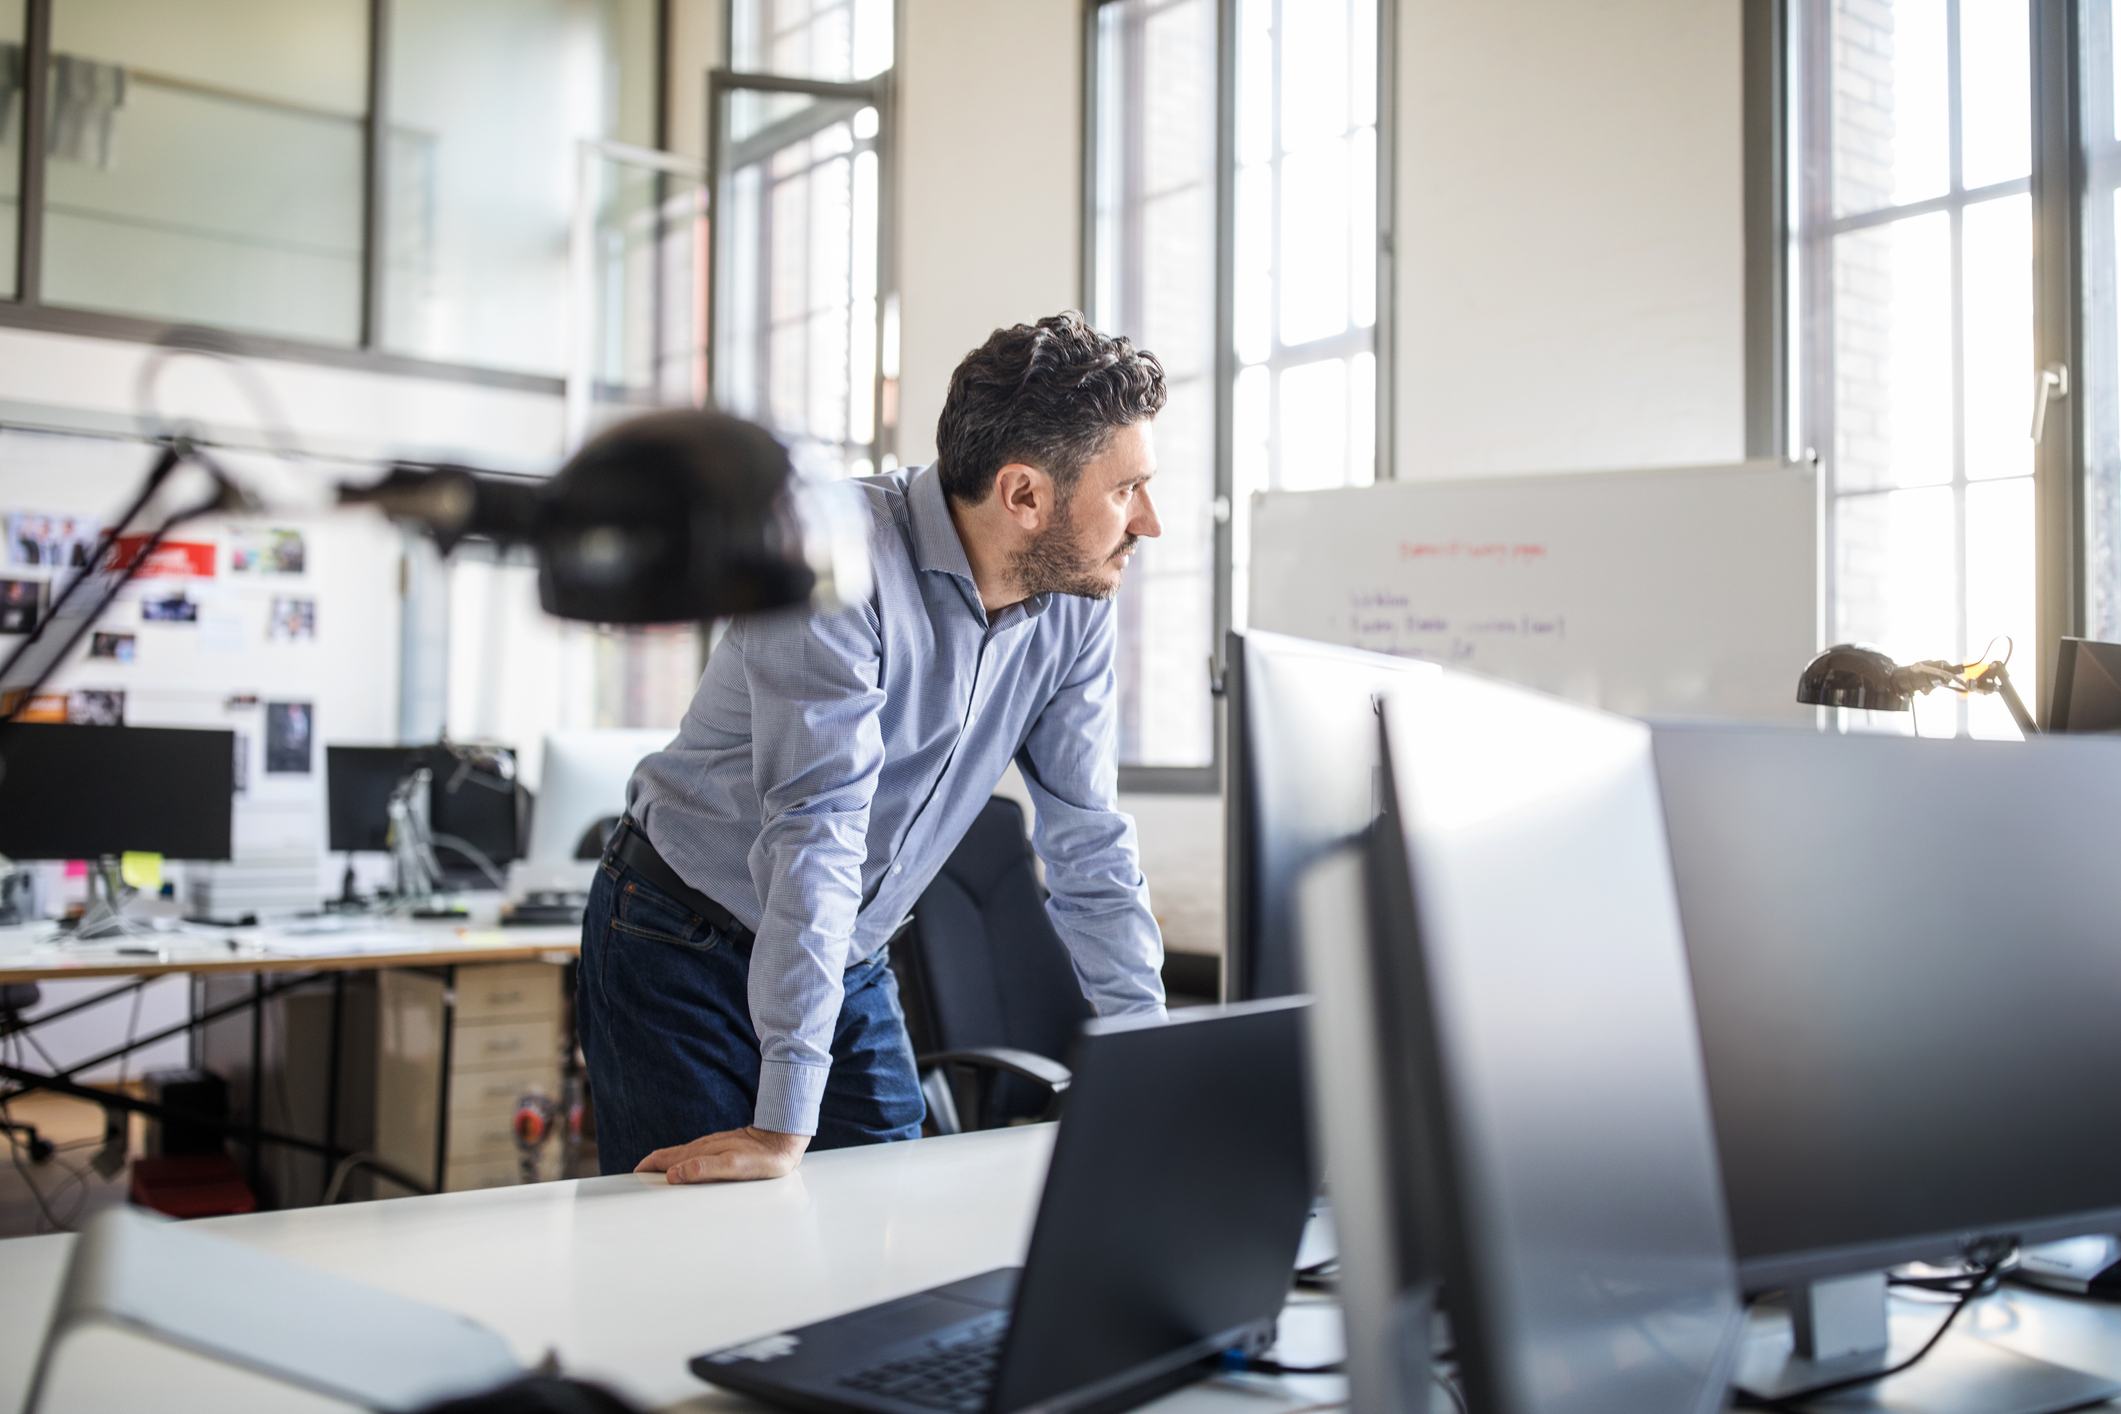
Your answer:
[708,0,895,475]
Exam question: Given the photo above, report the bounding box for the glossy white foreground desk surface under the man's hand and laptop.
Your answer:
[0,1126,1348,1414]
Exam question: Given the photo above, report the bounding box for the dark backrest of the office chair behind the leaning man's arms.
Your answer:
[891,795,1090,1128]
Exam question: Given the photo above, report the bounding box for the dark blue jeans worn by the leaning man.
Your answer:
[575,859,927,1174]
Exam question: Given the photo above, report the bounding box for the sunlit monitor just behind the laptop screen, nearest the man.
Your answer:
[1224,630,1436,1001]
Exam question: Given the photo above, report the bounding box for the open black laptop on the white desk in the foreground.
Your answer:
[691,998,1315,1414]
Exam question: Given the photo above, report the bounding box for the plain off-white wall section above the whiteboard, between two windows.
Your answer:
[1393,0,1746,477]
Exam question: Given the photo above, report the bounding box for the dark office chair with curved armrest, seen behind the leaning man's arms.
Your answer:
[891,795,1090,1134]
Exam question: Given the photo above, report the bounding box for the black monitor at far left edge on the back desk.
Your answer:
[0,723,235,861]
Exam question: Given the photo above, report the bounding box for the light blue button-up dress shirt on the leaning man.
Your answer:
[628,466,1164,1134]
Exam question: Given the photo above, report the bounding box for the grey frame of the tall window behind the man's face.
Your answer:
[1077,0,1400,795]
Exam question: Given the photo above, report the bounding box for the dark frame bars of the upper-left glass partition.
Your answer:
[0,0,672,396]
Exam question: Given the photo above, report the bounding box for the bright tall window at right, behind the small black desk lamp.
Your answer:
[1790,0,2036,736]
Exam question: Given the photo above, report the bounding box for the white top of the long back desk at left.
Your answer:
[0,918,581,982]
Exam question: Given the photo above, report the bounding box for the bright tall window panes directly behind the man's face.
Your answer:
[1088,0,1381,789]
